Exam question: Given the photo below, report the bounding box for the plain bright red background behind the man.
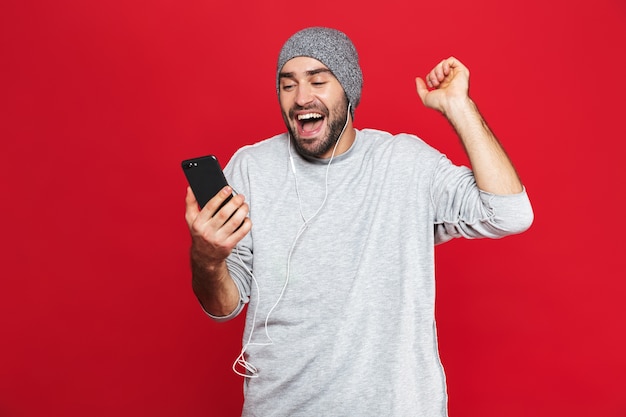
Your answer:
[0,0,626,417]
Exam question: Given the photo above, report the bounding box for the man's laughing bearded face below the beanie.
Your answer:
[278,57,348,158]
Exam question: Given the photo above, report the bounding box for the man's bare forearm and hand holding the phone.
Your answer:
[185,187,252,317]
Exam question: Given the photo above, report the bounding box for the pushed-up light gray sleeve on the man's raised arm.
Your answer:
[431,157,534,243]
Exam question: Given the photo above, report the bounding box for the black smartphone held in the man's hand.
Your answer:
[182,155,232,208]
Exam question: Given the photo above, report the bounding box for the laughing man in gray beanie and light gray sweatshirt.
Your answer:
[186,27,533,417]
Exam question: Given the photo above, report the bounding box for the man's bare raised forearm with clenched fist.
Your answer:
[415,57,523,194]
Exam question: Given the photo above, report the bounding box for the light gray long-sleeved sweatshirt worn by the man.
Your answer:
[215,130,533,417]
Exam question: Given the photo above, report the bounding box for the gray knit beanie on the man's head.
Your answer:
[276,27,363,118]
